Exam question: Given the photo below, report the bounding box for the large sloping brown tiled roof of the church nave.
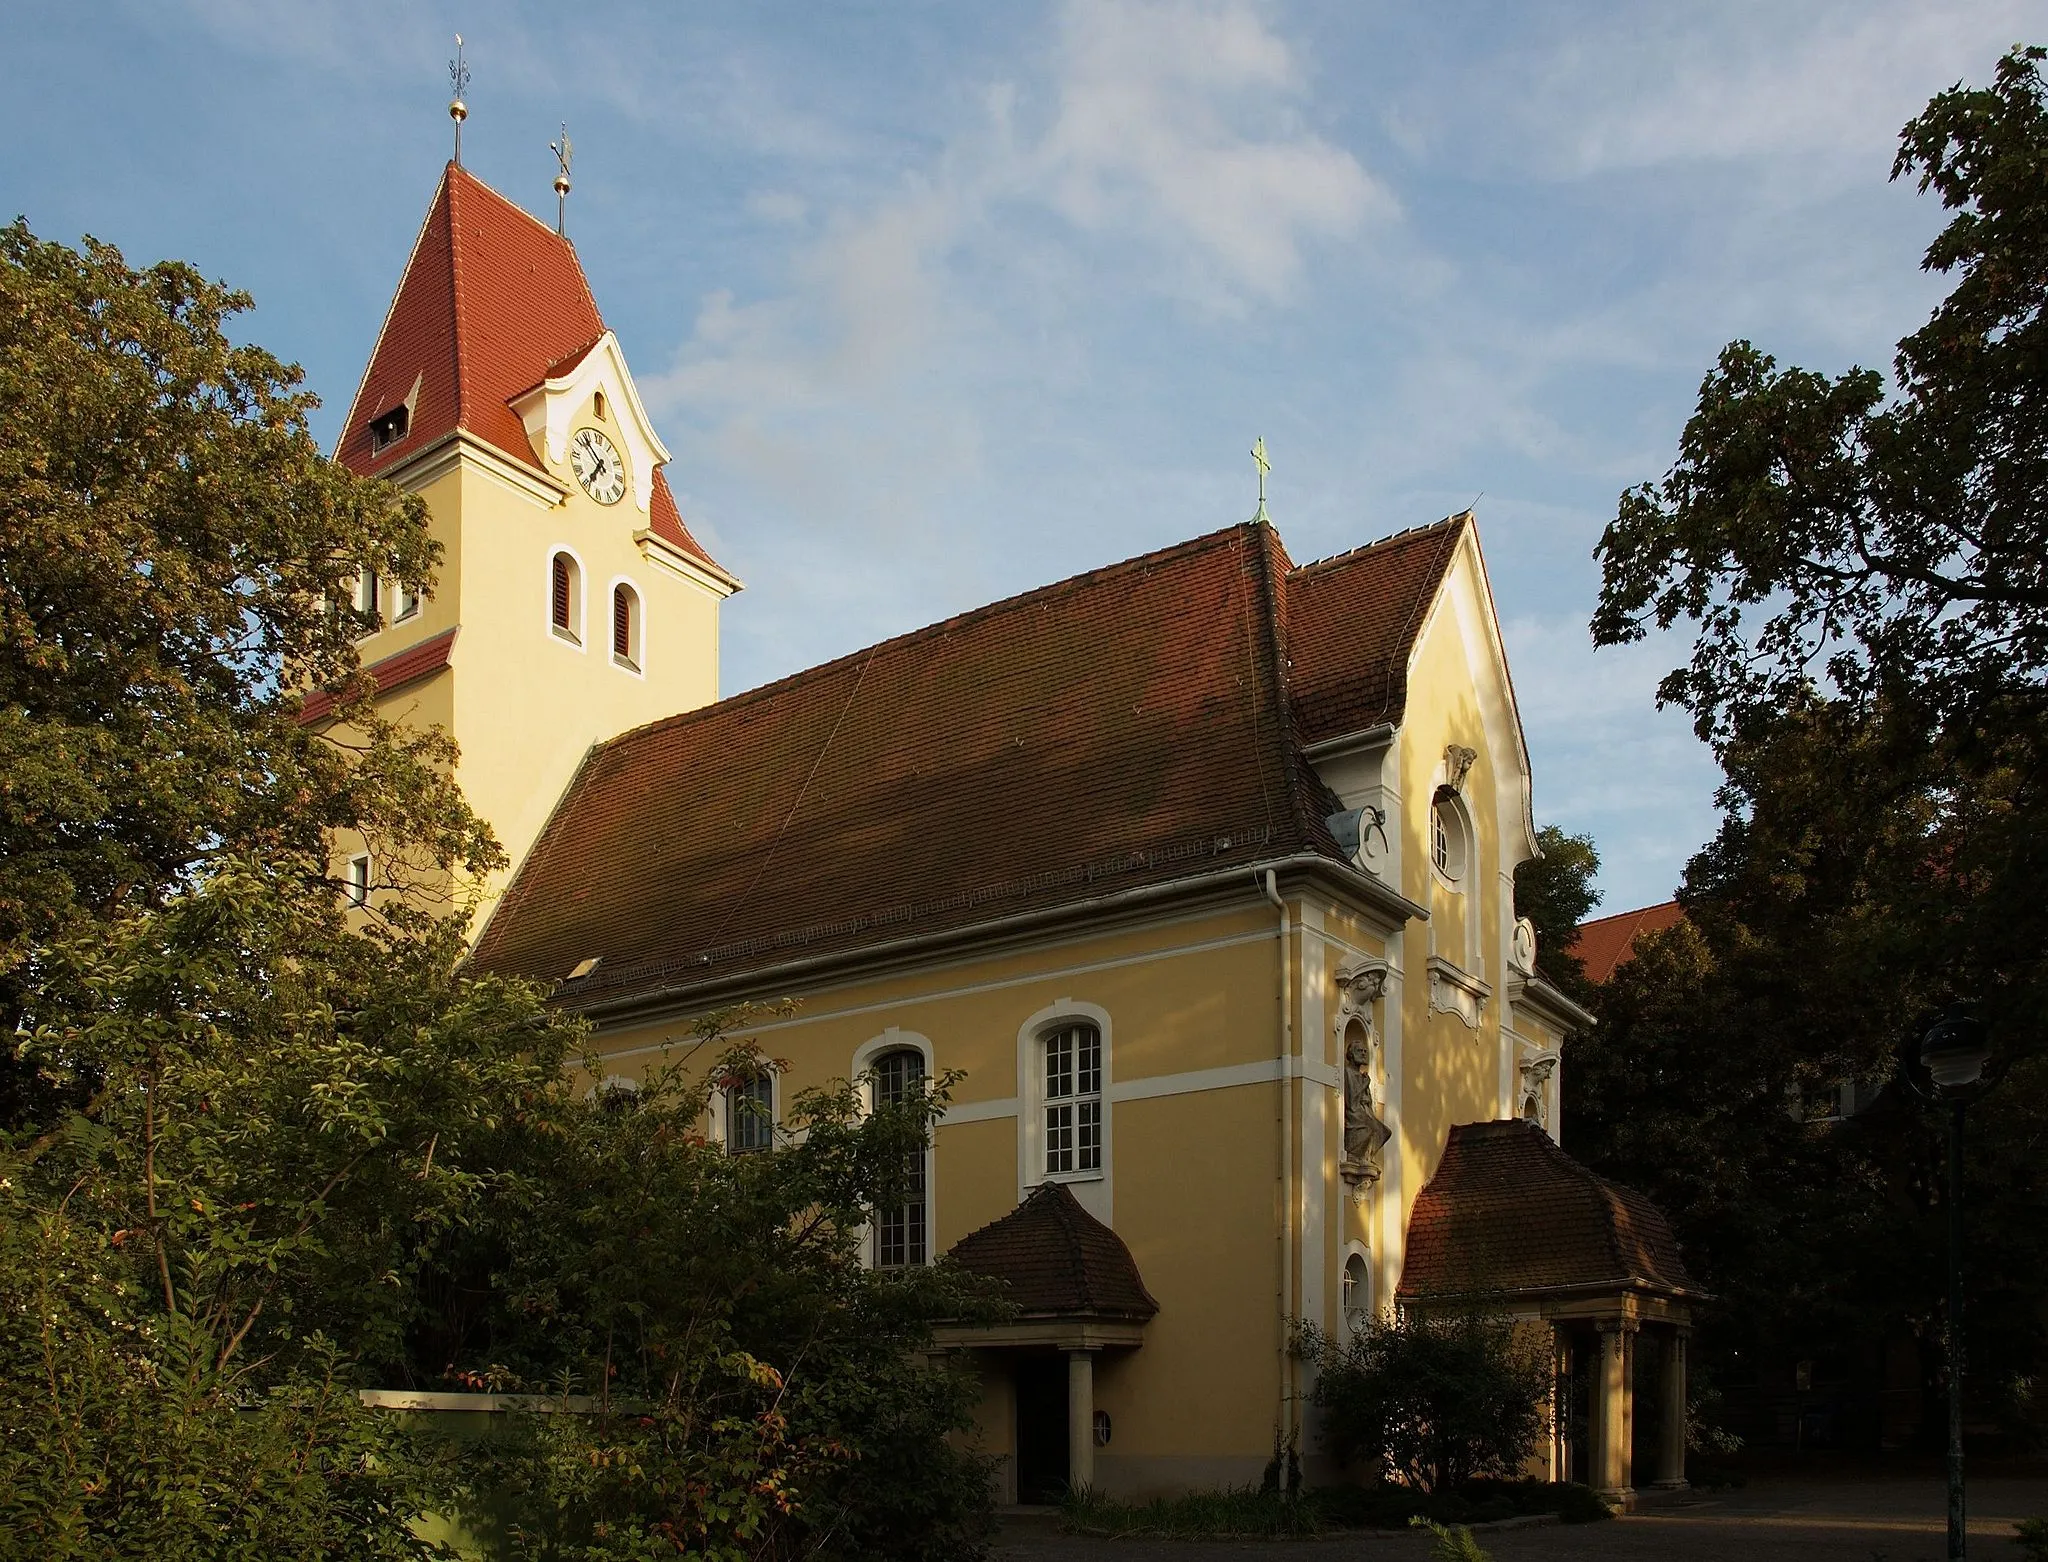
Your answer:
[475,522,1462,1007]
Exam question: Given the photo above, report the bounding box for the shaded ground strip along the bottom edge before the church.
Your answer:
[995,1476,2048,1562]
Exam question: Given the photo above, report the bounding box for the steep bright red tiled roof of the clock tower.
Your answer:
[346,162,723,573]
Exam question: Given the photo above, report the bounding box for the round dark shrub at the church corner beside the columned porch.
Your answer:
[1296,1314,1550,1492]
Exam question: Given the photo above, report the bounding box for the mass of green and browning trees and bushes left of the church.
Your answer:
[0,223,989,1562]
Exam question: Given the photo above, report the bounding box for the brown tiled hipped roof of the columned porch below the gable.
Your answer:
[1399,1122,1698,1302]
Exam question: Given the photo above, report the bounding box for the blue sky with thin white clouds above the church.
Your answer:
[0,0,2048,911]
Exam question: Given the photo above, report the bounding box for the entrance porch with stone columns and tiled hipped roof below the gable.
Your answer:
[1397,1122,1706,1509]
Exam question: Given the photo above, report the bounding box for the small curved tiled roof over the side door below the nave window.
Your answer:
[950,1183,1159,1320]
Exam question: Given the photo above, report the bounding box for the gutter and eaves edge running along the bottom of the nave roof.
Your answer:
[555,852,1430,1024]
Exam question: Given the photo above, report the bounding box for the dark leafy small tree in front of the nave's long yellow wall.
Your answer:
[414,1026,1001,1562]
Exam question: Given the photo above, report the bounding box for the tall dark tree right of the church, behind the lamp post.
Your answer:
[1567,47,2048,1441]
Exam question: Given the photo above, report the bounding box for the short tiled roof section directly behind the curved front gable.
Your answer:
[1286,516,1468,743]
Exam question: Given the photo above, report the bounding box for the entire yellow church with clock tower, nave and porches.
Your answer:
[319,164,1696,1501]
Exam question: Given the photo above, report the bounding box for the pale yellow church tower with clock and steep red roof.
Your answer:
[319,162,739,893]
